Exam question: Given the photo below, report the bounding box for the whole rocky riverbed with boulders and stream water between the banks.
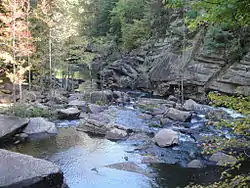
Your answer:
[0,91,247,188]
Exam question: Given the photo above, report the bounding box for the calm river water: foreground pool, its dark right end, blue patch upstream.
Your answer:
[6,103,233,188]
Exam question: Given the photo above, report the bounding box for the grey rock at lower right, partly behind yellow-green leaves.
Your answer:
[209,152,237,166]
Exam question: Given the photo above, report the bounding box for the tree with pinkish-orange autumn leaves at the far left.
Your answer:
[0,0,35,103]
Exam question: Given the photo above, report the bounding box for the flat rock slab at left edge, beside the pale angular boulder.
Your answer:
[0,115,29,143]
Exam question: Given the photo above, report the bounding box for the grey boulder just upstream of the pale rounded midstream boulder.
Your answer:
[164,108,192,122]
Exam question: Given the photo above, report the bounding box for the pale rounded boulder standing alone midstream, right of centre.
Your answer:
[153,129,179,147]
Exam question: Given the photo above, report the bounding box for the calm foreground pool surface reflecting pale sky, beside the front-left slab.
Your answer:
[11,128,152,188]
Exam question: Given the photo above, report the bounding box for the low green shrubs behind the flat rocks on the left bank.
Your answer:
[5,103,55,118]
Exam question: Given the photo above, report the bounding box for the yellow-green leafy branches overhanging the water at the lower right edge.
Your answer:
[194,93,250,188]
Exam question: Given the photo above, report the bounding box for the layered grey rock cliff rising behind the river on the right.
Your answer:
[92,12,250,101]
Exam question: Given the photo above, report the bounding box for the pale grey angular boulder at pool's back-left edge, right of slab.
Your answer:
[23,117,58,135]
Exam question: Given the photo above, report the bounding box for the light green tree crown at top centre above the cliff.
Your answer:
[111,0,149,50]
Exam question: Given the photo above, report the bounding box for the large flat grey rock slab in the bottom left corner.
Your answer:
[0,149,63,188]
